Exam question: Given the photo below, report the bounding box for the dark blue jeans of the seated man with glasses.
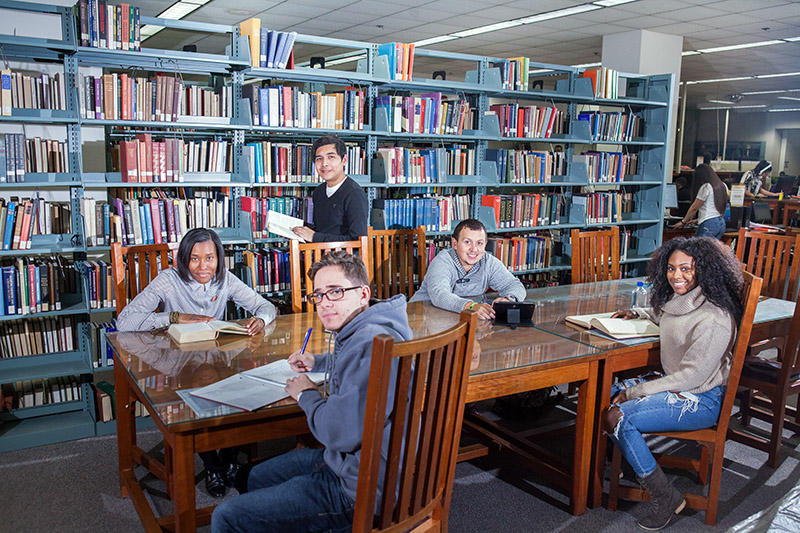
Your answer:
[211,449,355,533]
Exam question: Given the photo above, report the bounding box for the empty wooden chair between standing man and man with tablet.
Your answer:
[367,226,427,299]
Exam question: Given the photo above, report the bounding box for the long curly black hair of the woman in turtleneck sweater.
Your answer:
[647,237,744,323]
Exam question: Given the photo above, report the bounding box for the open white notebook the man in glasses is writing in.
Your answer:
[192,359,325,411]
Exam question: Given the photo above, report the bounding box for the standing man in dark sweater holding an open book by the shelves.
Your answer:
[292,135,369,242]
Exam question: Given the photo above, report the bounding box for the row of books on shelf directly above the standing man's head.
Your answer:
[242,84,366,130]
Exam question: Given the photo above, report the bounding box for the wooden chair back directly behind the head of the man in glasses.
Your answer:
[289,236,372,313]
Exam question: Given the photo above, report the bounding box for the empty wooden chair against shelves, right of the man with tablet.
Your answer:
[570,226,619,283]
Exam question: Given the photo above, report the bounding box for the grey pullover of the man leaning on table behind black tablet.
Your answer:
[410,248,526,313]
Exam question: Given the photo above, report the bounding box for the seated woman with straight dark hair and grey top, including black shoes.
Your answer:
[117,228,276,498]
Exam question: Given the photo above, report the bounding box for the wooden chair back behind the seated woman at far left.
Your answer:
[111,242,178,316]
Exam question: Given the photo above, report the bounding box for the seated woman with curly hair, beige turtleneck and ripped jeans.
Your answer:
[603,237,744,530]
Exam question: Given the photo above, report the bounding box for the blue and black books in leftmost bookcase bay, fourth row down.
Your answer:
[0,256,77,316]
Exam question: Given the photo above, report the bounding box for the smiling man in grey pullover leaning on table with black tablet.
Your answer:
[410,218,526,320]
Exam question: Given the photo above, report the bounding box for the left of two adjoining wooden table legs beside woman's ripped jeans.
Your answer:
[570,361,598,515]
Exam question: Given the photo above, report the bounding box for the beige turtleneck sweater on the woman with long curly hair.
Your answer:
[627,287,736,399]
